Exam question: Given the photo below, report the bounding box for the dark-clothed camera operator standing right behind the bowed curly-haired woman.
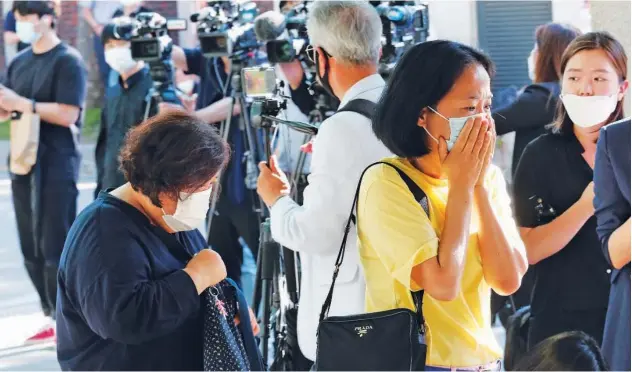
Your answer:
[169,40,260,287]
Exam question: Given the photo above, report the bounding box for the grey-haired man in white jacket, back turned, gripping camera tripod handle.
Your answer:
[257,1,391,360]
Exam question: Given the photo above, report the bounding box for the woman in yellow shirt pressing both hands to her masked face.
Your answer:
[357,41,527,370]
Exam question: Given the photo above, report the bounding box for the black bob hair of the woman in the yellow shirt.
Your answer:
[373,40,494,158]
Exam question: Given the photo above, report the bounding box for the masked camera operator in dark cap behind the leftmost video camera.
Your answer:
[94,17,157,198]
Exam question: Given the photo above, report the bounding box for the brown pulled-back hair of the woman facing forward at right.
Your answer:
[551,32,628,134]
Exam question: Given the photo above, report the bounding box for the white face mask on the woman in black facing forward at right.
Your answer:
[560,94,618,128]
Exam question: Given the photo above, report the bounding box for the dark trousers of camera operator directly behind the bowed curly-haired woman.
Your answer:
[208,191,260,287]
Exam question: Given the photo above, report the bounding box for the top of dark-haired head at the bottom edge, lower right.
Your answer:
[512,331,608,371]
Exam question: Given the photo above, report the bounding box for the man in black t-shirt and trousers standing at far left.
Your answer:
[0,1,86,341]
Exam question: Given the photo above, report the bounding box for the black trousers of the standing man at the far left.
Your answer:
[11,171,78,317]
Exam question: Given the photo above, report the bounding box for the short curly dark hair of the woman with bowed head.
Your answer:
[119,112,230,208]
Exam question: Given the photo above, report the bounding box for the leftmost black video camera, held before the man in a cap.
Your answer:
[114,12,187,103]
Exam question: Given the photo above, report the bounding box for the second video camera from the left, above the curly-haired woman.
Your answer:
[191,1,259,61]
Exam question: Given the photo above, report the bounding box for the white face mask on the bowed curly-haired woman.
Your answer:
[162,187,213,232]
